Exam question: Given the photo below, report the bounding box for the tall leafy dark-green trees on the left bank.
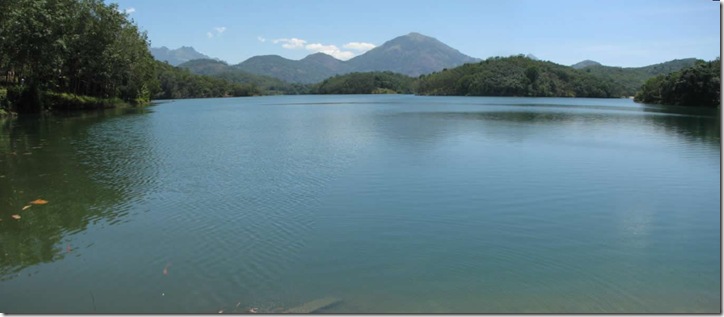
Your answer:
[0,0,158,111]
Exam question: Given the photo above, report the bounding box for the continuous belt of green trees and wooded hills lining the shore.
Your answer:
[0,0,721,114]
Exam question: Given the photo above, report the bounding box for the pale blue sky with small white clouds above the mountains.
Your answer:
[106,0,720,67]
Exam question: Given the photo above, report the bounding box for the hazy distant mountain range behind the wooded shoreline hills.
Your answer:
[151,32,696,89]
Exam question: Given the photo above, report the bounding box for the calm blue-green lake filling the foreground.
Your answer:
[0,95,721,313]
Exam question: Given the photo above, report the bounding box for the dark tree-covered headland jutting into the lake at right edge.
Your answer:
[634,58,721,107]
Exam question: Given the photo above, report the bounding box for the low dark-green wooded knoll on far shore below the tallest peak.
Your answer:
[310,72,414,94]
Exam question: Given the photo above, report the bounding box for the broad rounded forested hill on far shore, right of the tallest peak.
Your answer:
[417,55,623,98]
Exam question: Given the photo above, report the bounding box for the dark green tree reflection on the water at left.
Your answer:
[0,109,153,280]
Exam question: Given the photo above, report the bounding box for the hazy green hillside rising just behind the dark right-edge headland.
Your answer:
[576,58,697,96]
